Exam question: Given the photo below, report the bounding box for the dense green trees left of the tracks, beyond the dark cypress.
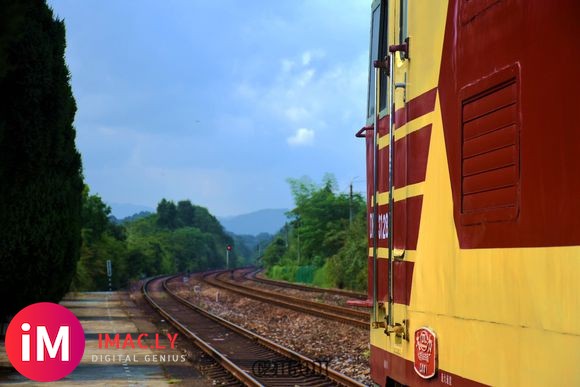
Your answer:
[74,197,242,290]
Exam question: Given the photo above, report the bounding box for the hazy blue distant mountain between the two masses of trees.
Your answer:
[218,209,288,235]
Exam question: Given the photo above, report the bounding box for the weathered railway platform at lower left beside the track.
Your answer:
[0,292,207,386]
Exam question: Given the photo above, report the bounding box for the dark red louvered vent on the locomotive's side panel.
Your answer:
[461,78,520,225]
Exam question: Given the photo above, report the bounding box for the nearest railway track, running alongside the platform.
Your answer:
[142,277,363,386]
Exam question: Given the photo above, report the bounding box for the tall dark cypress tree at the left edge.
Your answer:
[0,0,83,321]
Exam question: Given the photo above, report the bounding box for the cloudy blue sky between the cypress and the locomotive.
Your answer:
[48,0,371,216]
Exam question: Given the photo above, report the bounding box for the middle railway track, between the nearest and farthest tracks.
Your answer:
[203,271,370,329]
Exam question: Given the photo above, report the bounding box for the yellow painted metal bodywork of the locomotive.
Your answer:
[369,0,580,386]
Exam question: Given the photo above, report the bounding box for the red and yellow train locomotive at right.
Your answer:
[357,0,580,386]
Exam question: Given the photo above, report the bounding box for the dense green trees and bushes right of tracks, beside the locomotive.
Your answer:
[262,176,367,290]
